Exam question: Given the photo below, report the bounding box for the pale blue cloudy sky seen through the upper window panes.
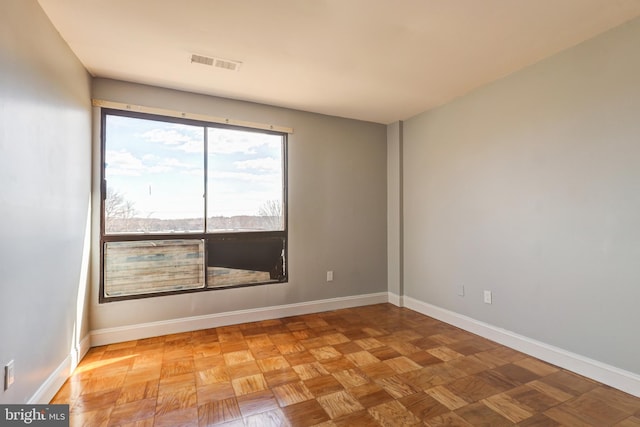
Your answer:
[105,116,282,219]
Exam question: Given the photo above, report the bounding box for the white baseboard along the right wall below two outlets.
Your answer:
[404,296,640,397]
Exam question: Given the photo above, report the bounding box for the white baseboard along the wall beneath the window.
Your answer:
[91,292,389,346]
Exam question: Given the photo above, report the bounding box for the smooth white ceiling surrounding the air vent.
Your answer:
[39,0,640,123]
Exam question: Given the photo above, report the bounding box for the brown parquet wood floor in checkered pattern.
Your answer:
[52,304,640,427]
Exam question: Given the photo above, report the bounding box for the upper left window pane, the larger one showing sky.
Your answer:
[104,115,204,233]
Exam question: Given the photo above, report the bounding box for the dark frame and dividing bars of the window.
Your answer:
[98,108,289,304]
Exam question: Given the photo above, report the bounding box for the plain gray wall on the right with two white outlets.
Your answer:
[404,20,640,374]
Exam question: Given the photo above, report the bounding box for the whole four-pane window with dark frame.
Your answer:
[100,109,287,302]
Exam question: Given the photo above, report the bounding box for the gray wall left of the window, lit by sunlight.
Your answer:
[0,0,91,403]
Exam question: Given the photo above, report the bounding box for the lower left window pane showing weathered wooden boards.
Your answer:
[104,240,204,297]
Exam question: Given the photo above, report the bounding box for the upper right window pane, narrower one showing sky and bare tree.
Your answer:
[207,128,284,232]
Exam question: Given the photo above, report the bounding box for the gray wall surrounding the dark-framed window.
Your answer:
[91,79,387,330]
